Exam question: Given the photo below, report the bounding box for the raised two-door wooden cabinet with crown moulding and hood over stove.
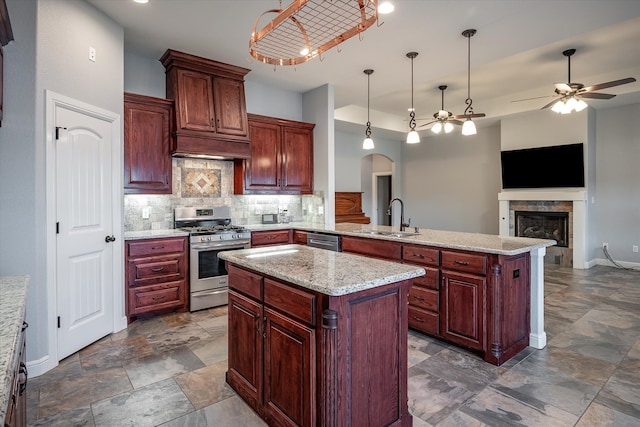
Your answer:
[160,49,250,159]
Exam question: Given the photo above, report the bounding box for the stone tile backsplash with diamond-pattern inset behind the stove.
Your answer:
[124,158,324,231]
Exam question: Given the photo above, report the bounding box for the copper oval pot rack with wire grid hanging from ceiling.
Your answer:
[249,0,380,66]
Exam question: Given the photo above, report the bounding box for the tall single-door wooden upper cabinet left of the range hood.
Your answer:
[124,93,173,194]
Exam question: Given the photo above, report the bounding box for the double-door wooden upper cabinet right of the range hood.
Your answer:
[234,114,315,194]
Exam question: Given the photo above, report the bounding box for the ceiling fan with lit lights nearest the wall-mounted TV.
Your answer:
[541,49,636,114]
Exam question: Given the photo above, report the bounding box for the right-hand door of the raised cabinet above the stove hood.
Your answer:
[213,77,248,136]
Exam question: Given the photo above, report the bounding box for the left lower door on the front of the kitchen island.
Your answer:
[227,291,263,408]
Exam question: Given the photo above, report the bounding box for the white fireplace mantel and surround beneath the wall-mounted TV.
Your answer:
[498,190,588,269]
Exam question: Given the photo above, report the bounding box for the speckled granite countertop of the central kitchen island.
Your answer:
[218,245,425,296]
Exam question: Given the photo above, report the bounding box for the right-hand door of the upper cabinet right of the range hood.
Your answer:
[281,126,313,194]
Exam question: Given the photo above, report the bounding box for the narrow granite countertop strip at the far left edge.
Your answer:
[0,276,29,425]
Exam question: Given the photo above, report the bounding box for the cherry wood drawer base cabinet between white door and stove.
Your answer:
[125,237,189,322]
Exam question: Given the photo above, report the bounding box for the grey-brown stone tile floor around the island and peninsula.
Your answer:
[27,265,640,427]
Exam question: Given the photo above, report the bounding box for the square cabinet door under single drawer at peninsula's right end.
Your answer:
[440,271,487,350]
